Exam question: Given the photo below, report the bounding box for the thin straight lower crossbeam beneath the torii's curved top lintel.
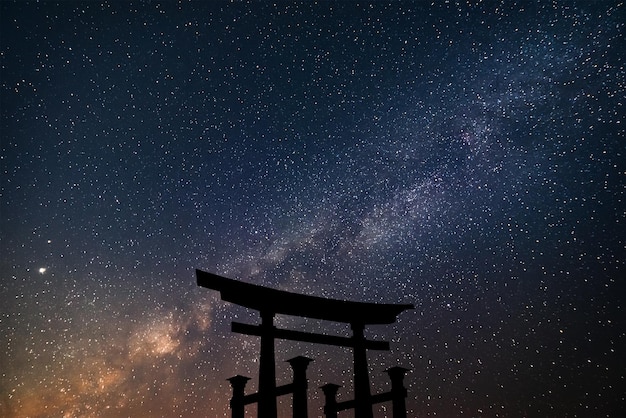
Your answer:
[231,322,389,351]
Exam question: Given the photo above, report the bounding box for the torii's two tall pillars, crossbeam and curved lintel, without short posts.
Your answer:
[196,270,413,418]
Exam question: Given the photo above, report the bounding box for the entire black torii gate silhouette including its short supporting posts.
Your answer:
[196,270,413,418]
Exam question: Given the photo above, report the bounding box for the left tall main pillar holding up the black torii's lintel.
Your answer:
[257,311,278,418]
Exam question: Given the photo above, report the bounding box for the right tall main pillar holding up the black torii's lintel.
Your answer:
[351,323,374,418]
